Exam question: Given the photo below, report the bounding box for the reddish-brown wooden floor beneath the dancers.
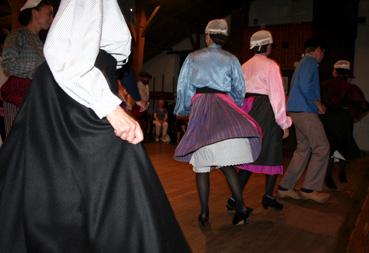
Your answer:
[145,143,369,253]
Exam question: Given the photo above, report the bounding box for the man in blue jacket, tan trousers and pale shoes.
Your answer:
[278,38,330,203]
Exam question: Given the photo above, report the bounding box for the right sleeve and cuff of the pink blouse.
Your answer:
[268,64,292,129]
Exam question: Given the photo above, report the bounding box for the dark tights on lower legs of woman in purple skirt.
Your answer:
[196,166,246,217]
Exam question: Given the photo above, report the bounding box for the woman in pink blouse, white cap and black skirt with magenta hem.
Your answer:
[227,30,292,210]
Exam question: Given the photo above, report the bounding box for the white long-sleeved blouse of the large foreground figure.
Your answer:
[44,0,131,118]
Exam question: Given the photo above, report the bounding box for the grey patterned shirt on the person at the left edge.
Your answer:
[2,27,45,79]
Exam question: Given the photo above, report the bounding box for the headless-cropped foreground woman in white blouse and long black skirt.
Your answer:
[0,0,190,253]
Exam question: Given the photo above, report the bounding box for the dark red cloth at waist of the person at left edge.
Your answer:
[1,76,32,107]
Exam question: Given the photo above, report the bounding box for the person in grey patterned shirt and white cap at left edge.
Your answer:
[1,0,54,134]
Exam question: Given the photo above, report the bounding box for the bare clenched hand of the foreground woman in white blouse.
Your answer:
[106,106,143,144]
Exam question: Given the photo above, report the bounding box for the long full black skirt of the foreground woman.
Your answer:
[0,60,190,253]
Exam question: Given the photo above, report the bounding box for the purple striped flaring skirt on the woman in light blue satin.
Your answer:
[174,93,263,162]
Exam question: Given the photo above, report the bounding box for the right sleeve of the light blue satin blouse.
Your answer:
[230,58,246,106]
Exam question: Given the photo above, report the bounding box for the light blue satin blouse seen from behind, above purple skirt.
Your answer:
[174,43,245,116]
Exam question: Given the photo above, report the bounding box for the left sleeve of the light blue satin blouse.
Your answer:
[174,55,196,116]
